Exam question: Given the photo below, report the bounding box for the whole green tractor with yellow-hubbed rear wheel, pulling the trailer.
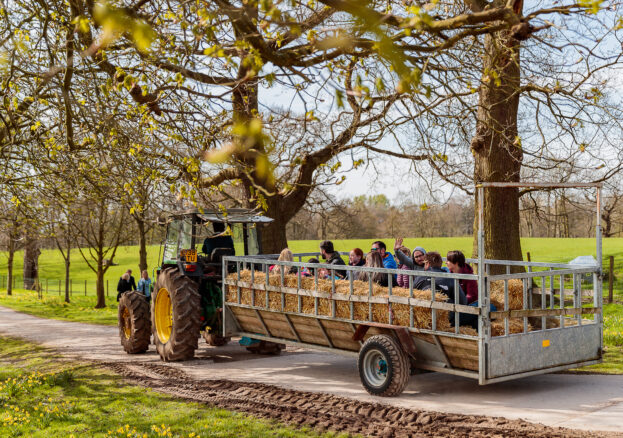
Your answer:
[119,209,272,361]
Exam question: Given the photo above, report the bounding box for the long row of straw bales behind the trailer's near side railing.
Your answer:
[225,270,450,330]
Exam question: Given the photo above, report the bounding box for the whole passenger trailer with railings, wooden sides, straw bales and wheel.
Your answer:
[222,183,603,396]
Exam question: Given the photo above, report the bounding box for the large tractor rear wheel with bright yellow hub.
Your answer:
[151,268,201,362]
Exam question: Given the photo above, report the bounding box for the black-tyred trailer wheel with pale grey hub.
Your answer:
[357,335,410,397]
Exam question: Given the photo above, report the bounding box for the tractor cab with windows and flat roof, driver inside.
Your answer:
[161,209,272,277]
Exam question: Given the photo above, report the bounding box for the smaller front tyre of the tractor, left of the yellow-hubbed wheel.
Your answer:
[118,291,151,354]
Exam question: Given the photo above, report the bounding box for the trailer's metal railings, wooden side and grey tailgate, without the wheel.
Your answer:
[222,183,603,395]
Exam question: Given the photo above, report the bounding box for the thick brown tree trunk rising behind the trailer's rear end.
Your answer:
[472,8,523,274]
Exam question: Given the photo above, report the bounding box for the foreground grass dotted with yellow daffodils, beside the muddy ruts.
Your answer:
[0,337,344,438]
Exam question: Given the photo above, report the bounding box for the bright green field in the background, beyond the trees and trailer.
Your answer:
[0,237,623,297]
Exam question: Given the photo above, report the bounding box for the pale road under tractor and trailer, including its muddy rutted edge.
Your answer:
[0,307,623,437]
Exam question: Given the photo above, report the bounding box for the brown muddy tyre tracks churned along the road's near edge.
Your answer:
[99,362,615,438]
